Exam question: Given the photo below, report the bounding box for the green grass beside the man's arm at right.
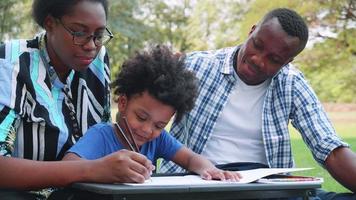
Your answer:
[291,112,356,192]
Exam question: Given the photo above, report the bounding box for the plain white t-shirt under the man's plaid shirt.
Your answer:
[202,73,270,164]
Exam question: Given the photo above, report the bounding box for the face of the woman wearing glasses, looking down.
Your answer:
[44,1,106,73]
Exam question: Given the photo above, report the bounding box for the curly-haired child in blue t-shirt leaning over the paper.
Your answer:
[64,46,239,182]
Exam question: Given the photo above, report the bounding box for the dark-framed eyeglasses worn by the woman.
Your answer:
[57,19,114,46]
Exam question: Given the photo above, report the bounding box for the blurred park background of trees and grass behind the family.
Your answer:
[0,0,356,192]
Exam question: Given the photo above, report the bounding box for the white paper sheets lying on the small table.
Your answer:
[124,168,312,186]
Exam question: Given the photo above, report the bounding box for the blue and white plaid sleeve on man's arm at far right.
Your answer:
[292,73,348,166]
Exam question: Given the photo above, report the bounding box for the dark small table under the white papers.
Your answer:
[71,180,321,200]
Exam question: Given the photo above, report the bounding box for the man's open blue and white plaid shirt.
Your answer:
[160,46,347,172]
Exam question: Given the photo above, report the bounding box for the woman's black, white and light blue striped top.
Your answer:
[0,35,110,160]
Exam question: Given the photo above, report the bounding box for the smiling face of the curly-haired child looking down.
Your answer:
[118,91,175,147]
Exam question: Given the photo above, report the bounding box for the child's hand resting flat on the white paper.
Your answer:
[200,168,242,181]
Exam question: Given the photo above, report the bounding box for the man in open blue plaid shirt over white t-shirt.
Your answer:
[161,8,356,195]
